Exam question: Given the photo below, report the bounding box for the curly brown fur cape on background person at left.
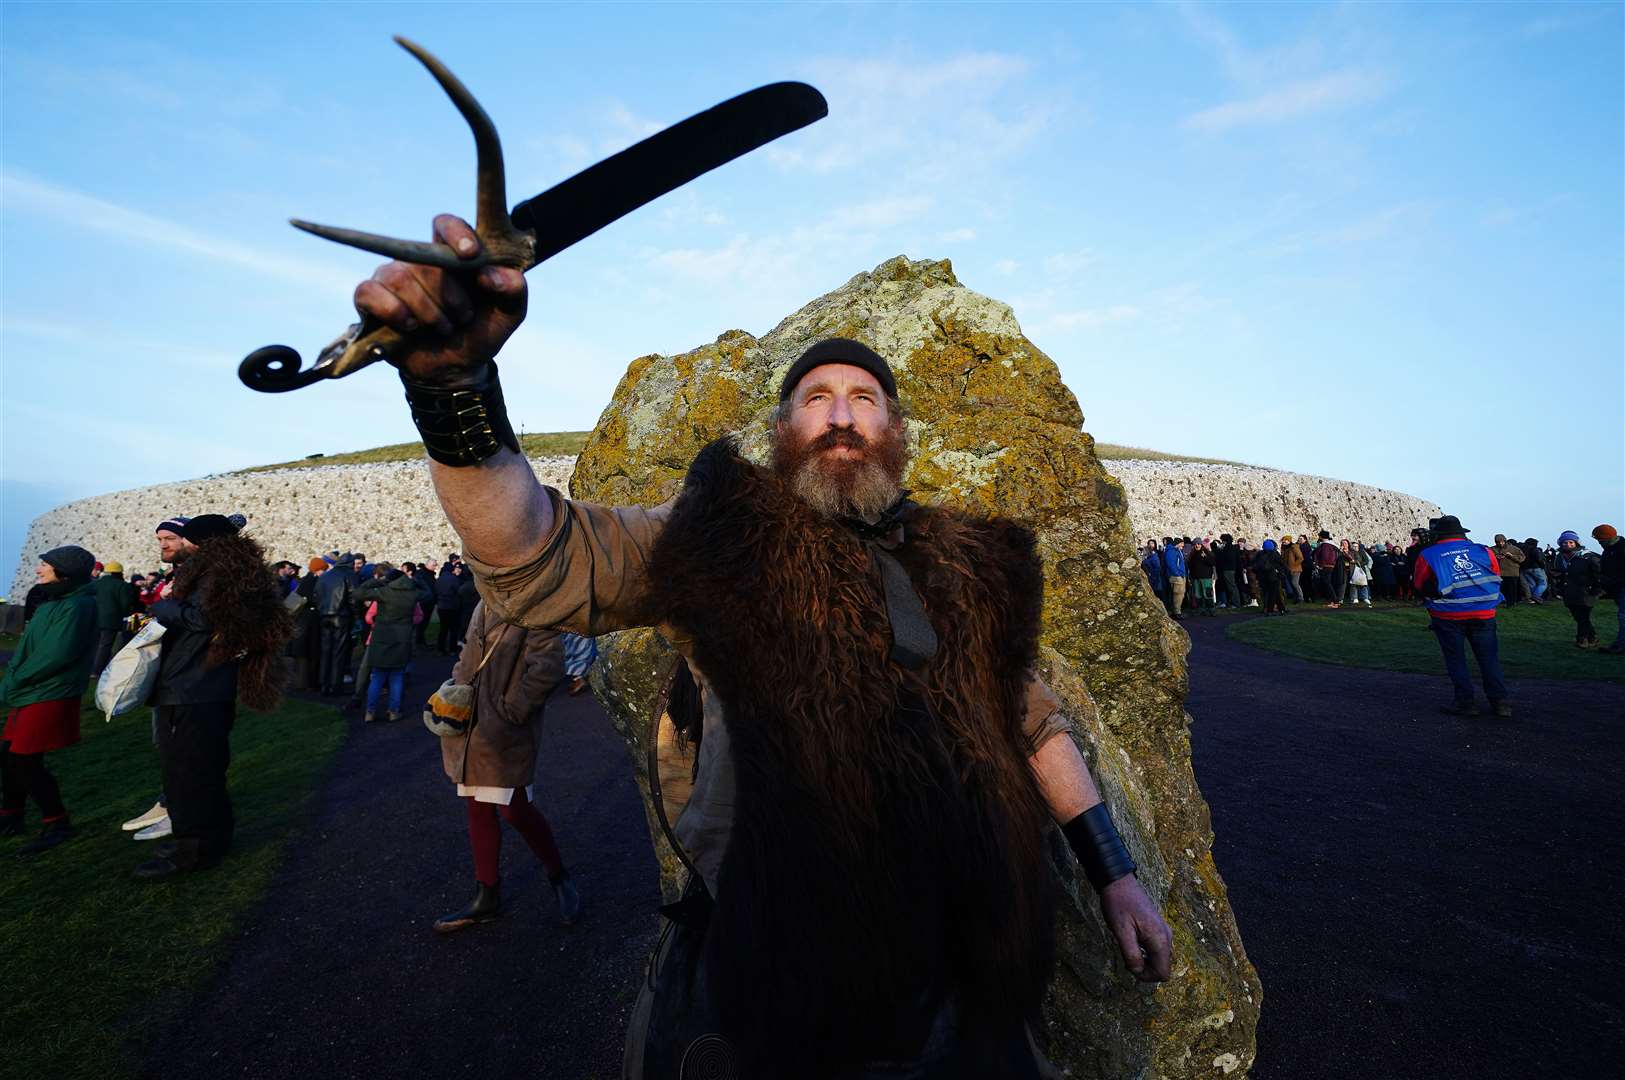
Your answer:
[174,534,294,713]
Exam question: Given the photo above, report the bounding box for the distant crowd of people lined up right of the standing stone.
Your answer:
[1139,525,1625,654]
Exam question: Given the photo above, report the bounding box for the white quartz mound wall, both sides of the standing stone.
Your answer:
[11,458,1438,599]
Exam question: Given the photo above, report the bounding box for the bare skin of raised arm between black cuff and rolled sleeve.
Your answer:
[429,450,553,567]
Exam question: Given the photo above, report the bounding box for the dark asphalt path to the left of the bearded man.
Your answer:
[143,654,660,1080]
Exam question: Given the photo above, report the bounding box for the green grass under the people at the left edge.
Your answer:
[0,685,345,1080]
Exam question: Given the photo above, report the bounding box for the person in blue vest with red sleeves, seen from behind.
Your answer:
[1412,515,1513,718]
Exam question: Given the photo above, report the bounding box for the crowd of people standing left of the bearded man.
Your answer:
[0,515,596,931]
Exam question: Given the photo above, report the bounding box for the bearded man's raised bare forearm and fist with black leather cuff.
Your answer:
[356,214,553,567]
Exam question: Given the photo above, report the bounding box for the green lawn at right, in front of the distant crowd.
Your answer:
[1227,604,1625,682]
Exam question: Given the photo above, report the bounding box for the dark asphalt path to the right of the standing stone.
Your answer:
[1185,612,1625,1080]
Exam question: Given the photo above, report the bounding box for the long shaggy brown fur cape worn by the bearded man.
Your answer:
[650,440,1053,1075]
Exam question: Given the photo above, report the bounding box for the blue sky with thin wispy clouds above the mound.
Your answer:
[0,2,1625,584]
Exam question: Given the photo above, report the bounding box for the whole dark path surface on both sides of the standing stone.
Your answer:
[145,614,1625,1080]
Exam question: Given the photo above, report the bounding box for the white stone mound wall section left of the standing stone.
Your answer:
[10,458,575,603]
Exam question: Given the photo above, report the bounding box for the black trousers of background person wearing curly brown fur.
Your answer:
[154,702,237,869]
